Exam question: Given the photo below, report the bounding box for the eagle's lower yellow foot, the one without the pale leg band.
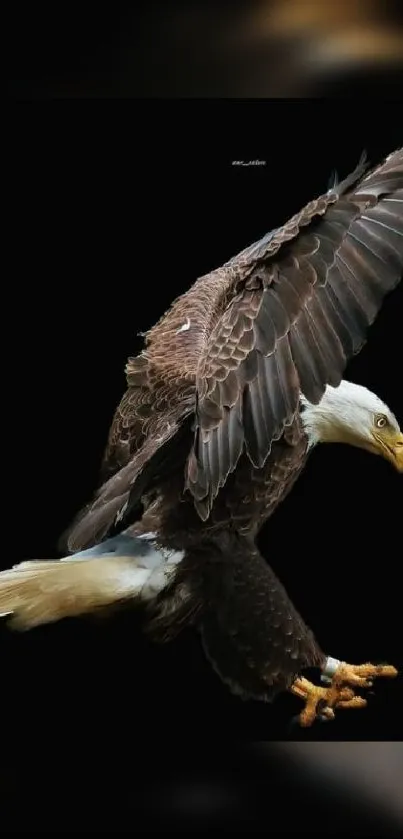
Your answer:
[291,677,367,728]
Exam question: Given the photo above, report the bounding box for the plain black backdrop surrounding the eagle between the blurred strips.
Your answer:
[0,101,403,823]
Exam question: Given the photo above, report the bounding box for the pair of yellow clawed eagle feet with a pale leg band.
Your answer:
[291,657,397,726]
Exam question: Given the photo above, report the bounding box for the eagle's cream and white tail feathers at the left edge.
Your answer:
[0,539,183,630]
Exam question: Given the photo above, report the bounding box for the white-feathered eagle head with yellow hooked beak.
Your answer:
[301,379,403,472]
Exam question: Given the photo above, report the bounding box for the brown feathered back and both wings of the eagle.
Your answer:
[62,150,403,551]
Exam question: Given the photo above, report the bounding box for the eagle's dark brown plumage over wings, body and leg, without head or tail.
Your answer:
[1,149,403,698]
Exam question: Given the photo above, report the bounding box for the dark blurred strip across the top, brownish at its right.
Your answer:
[3,0,403,102]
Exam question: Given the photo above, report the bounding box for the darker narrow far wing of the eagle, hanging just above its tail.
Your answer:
[60,356,194,552]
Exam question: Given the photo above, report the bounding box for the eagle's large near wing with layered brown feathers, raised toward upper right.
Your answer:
[186,149,403,519]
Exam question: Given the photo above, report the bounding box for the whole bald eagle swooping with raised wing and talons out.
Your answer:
[0,149,403,725]
